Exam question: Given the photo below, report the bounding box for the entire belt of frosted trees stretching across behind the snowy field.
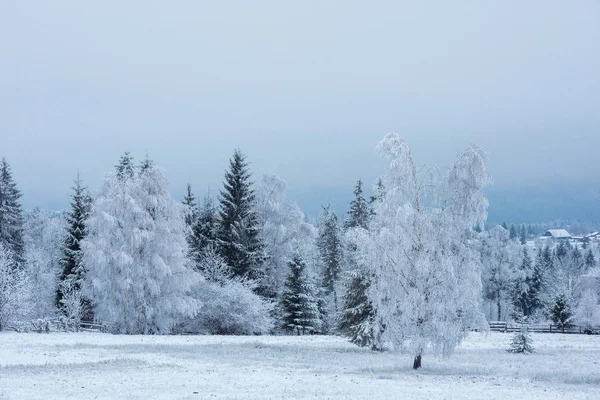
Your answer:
[0,134,597,368]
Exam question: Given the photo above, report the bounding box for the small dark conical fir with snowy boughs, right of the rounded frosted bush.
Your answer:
[282,253,321,335]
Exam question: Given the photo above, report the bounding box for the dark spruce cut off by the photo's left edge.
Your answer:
[0,158,25,269]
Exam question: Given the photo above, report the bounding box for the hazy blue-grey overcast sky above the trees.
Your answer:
[0,0,600,216]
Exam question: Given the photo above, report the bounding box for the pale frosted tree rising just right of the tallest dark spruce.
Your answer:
[256,175,317,296]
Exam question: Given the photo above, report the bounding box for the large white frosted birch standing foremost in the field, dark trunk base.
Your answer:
[359,134,490,368]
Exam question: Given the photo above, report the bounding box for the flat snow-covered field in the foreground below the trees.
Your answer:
[0,333,600,400]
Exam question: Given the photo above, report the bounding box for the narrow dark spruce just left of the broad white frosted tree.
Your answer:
[56,174,92,317]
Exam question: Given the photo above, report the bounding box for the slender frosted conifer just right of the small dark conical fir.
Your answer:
[317,206,344,313]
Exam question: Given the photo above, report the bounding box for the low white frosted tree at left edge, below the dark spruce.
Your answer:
[0,243,32,331]
